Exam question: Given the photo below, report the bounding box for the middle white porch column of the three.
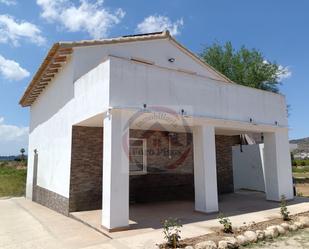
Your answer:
[193,125,219,213]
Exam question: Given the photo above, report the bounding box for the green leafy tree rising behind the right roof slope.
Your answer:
[200,42,289,93]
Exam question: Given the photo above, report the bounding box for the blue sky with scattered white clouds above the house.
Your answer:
[0,0,309,155]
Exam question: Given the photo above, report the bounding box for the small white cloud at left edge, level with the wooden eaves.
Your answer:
[0,55,30,80]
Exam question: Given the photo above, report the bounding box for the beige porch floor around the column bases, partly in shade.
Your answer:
[71,191,309,243]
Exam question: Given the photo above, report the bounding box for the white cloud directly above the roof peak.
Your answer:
[136,15,183,35]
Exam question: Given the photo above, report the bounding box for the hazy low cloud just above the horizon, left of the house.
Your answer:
[0,117,29,155]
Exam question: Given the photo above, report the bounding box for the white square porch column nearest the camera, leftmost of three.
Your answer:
[102,110,129,231]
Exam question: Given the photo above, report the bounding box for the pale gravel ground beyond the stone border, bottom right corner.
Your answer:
[246,228,309,249]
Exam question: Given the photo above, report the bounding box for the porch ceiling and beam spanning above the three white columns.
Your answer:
[74,108,283,136]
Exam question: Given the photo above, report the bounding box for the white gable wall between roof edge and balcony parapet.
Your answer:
[73,39,220,80]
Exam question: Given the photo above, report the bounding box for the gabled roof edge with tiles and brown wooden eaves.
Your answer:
[19,30,232,107]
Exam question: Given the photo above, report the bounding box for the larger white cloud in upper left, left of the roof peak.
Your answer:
[0,15,45,46]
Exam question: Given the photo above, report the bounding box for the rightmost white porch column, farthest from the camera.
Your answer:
[264,129,294,201]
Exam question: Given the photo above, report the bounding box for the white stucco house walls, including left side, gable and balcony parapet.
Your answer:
[27,40,287,200]
